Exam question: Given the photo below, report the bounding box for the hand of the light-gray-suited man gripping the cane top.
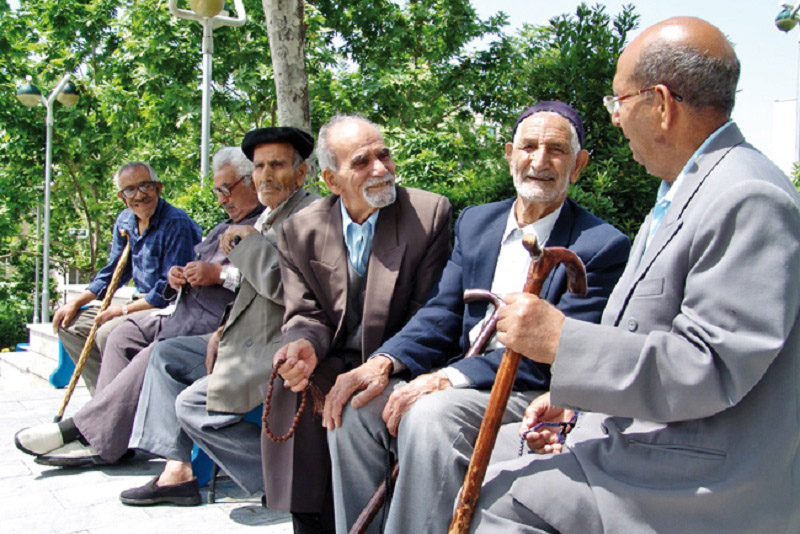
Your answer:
[497,293,564,364]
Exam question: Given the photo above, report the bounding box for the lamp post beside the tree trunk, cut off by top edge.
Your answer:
[167,0,247,184]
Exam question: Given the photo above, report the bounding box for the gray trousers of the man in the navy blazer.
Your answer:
[328,380,538,534]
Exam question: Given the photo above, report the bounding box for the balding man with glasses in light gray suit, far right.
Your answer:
[473,17,800,533]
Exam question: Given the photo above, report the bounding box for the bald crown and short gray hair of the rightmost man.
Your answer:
[620,17,739,120]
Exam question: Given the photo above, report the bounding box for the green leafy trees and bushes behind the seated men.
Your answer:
[0,0,657,344]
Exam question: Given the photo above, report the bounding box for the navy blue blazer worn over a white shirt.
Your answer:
[376,198,630,390]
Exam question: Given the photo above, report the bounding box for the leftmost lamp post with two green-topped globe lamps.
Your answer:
[17,73,78,323]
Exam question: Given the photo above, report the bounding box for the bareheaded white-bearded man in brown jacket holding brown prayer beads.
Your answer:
[272,116,451,532]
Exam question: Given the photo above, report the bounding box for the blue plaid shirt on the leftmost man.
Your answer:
[87,198,202,308]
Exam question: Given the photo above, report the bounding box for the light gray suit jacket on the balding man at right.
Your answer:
[543,125,800,534]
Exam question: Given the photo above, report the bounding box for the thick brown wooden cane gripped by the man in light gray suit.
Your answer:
[448,236,586,534]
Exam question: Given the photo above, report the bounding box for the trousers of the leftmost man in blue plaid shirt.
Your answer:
[58,306,153,395]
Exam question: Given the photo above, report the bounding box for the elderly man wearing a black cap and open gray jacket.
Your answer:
[120,127,319,505]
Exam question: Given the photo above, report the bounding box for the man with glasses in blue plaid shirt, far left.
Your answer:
[53,161,203,395]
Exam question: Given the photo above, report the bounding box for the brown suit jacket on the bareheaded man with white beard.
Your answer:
[261,187,452,513]
